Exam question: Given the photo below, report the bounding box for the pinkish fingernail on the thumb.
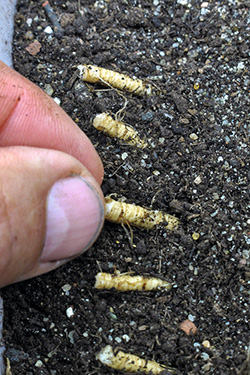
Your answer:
[41,176,104,262]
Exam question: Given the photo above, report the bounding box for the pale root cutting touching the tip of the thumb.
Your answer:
[105,196,179,230]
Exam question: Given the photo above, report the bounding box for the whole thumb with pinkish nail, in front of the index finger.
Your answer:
[0,146,104,287]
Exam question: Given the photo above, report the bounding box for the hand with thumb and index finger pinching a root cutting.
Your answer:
[0,61,104,287]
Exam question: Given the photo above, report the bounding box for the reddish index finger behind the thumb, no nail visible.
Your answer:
[0,61,103,184]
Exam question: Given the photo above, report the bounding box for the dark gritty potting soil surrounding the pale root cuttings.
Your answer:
[0,0,250,375]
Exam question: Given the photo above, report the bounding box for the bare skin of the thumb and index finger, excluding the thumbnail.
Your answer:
[0,62,104,287]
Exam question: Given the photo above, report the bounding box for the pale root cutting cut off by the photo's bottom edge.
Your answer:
[96,345,179,375]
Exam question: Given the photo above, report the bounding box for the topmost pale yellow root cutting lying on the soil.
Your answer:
[78,65,152,96]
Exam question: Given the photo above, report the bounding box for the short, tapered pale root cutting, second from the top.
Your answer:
[93,113,148,148]
